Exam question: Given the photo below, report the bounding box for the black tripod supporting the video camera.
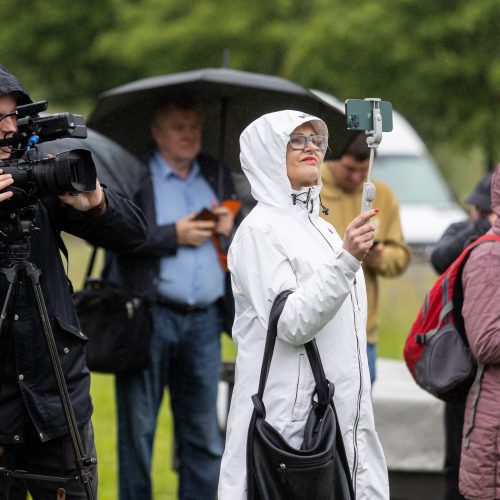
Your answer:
[0,207,97,500]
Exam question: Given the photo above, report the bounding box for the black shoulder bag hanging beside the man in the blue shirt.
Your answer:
[73,248,153,374]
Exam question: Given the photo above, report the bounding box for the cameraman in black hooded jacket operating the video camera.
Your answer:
[0,65,146,500]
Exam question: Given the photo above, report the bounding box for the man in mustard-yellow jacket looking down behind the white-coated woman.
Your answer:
[321,133,410,384]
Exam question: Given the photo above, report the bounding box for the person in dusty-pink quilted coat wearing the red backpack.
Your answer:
[459,164,500,500]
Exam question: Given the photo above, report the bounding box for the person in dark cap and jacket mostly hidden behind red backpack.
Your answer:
[431,172,496,500]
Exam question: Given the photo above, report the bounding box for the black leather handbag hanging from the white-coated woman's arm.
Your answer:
[247,291,355,500]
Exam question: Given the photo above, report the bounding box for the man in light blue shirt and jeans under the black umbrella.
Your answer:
[105,102,235,500]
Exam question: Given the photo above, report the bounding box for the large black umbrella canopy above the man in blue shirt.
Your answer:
[89,68,355,172]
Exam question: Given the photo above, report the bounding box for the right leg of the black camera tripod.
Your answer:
[26,262,97,500]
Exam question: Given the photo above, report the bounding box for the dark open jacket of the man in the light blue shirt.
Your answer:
[103,155,237,333]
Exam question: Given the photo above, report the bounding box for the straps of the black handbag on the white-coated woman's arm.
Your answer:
[252,290,334,418]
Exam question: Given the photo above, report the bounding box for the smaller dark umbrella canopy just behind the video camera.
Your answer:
[37,128,147,198]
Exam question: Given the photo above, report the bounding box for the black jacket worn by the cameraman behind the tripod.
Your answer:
[0,190,146,444]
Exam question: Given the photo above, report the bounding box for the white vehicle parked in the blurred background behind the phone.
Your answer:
[312,90,467,254]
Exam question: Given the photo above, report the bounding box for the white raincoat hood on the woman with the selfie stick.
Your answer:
[240,110,328,213]
